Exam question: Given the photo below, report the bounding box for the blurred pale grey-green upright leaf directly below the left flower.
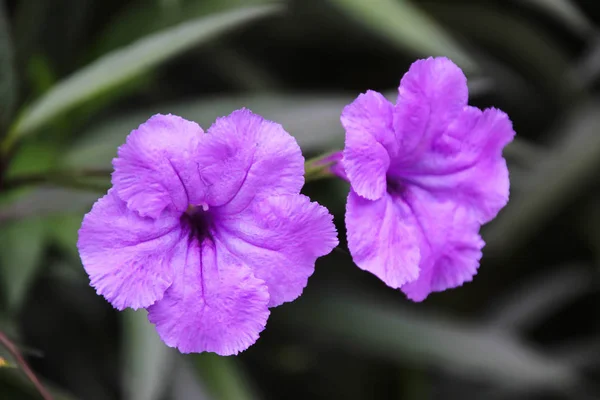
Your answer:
[123,310,174,400]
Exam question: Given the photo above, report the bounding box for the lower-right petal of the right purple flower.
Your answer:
[401,187,485,301]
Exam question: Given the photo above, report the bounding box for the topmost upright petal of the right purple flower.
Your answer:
[393,57,468,167]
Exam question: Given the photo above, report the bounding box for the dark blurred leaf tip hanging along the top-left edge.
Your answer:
[0,4,17,128]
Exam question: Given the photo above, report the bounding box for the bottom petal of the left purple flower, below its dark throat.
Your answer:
[148,238,269,356]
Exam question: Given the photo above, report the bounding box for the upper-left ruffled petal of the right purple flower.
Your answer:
[341,91,398,200]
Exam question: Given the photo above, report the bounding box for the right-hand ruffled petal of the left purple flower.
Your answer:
[216,195,338,307]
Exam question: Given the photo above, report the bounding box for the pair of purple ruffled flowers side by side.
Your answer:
[78,58,514,355]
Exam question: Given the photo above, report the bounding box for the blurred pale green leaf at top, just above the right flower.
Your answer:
[329,0,477,72]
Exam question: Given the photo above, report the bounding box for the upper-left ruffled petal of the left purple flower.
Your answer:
[112,114,203,218]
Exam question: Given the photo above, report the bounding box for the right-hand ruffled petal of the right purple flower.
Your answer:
[402,107,515,223]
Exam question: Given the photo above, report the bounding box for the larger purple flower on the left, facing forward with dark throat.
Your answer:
[78,110,338,355]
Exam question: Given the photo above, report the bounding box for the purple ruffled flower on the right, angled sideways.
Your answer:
[341,58,515,301]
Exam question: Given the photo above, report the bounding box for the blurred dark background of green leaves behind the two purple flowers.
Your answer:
[0,0,600,400]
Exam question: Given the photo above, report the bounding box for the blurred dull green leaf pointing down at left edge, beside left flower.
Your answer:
[0,218,46,311]
